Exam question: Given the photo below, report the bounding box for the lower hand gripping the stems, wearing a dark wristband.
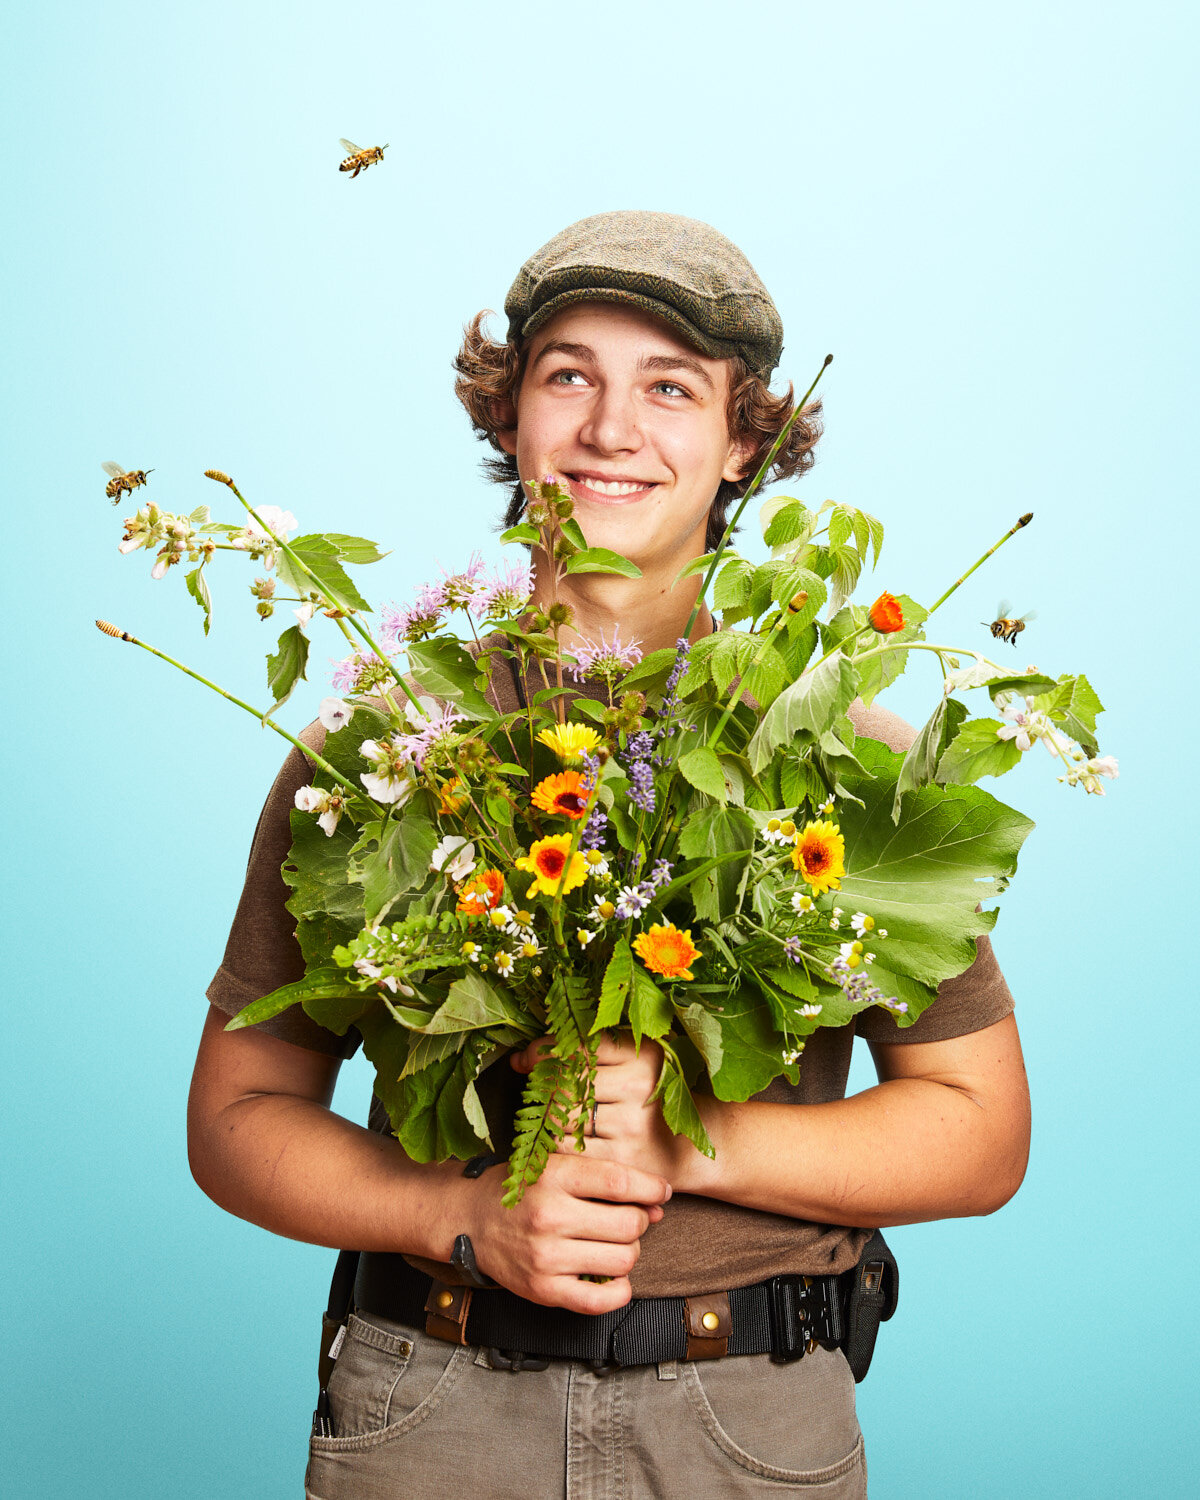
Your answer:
[464,1152,671,1313]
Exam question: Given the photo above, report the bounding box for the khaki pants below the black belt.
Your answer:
[305,1316,867,1500]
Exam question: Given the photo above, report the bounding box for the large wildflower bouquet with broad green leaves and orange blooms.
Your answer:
[101,404,1116,1203]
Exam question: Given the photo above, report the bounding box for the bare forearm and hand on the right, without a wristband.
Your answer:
[528,1016,1029,1227]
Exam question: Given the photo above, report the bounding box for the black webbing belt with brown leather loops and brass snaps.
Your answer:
[354,1251,846,1370]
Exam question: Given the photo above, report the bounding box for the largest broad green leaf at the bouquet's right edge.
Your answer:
[839,740,1034,986]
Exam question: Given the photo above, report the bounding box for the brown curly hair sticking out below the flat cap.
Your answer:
[455,311,822,552]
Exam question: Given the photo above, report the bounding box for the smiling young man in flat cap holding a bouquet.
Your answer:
[189,213,1029,1500]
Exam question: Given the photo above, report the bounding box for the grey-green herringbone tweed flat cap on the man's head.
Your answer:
[504,210,783,380]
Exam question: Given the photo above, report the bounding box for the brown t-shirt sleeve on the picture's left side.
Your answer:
[206,723,360,1058]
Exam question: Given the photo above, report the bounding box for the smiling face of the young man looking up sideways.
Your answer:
[500,302,743,569]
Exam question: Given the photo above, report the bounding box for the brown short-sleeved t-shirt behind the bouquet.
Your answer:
[207,665,1013,1298]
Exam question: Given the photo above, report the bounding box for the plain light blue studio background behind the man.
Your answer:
[2,0,1197,1500]
